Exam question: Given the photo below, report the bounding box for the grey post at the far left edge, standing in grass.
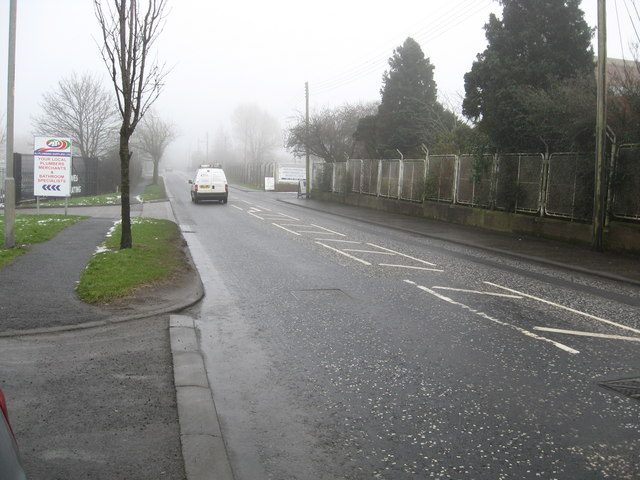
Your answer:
[4,0,18,253]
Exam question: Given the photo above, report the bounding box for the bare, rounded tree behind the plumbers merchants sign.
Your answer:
[32,72,116,158]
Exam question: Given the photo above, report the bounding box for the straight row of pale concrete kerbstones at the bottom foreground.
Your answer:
[169,315,233,480]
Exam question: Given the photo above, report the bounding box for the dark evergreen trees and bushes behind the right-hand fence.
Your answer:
[286,0,640,162]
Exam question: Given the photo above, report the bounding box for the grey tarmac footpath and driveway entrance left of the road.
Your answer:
[0,202,209,480]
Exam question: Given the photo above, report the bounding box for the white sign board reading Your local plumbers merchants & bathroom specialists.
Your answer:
[33,137,71,197]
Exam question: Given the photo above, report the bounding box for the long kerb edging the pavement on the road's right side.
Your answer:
[278,198,640,286]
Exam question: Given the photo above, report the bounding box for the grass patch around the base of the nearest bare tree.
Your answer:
[77,218,187,303]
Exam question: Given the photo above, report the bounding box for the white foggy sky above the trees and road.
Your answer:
[0,0,638,165]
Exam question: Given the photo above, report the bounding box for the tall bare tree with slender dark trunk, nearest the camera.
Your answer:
[94,0,167,249]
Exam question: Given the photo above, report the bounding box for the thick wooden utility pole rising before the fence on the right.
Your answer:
[591,0,607,252]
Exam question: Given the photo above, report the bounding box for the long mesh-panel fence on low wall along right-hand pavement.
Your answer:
[311,145,640,222]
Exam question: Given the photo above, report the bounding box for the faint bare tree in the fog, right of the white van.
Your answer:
[231,104,282,163]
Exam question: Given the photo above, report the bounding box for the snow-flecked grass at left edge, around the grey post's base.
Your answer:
[0,215,87,268]
